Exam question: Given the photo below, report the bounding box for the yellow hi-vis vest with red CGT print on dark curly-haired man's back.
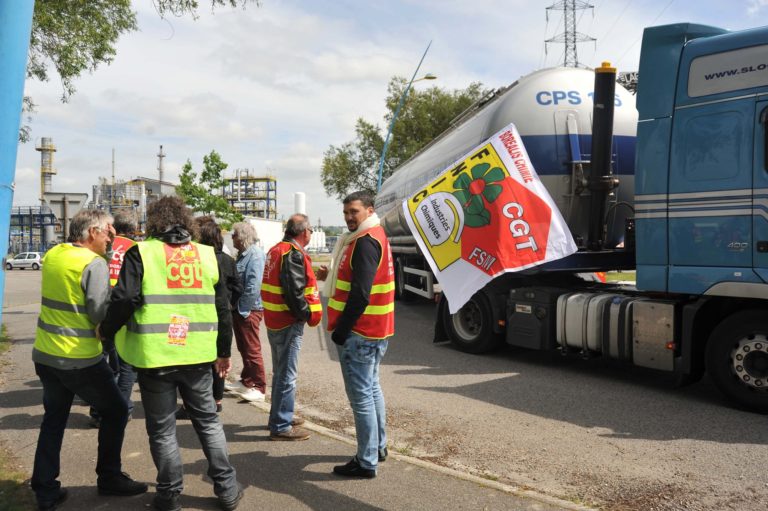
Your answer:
[115,239,219,369]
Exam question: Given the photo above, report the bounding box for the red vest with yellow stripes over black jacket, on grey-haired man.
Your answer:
[261,240,323,330]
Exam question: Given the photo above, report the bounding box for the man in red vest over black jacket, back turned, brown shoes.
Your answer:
[261,214,327,441]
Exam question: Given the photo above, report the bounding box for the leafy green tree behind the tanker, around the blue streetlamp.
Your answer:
[320,76,486,200]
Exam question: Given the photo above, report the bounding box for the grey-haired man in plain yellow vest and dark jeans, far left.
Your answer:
[32,209,147,511]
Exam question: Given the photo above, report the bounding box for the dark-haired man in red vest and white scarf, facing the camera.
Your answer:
[324,192,395,478]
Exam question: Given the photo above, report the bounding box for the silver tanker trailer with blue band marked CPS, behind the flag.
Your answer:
[376,68,637,352]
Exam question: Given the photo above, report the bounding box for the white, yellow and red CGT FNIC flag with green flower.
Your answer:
[403,124,577,313]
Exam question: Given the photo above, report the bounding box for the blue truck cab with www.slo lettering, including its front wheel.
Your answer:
[635,24,768,412]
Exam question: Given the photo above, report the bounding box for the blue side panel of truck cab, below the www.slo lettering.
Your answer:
[668,97,752,293]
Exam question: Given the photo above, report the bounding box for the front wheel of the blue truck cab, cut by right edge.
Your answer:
[706,310,768,413]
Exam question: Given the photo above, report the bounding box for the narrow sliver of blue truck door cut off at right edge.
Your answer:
[750,101,768,276]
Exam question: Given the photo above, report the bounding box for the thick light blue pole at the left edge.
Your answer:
[0,0,35,321]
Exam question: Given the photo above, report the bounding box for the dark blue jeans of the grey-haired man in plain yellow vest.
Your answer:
[32,360,128,504]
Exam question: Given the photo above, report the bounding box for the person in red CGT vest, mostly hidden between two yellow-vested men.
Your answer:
[89,211,138,428]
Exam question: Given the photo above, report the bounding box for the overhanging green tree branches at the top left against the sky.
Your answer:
[19,0,259,142]
